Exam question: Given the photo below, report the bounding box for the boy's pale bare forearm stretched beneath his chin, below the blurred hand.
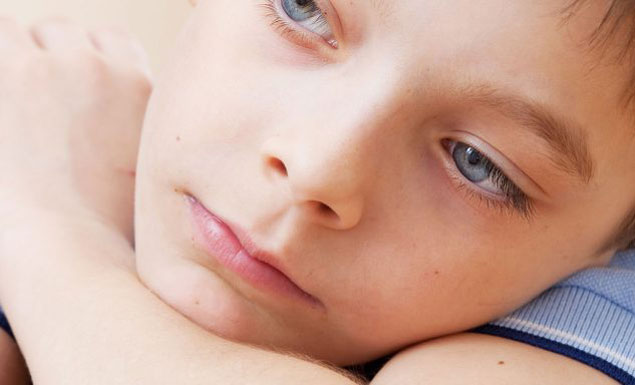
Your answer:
[0,219,362,385]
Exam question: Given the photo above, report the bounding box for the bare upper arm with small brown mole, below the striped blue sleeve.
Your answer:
[371,333,618,385]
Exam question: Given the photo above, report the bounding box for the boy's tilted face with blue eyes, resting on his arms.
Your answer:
[137,0,635,365]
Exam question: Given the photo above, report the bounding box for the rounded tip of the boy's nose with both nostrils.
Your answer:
[262,138,364,230]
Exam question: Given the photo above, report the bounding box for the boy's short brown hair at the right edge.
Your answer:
[563,0,635,249]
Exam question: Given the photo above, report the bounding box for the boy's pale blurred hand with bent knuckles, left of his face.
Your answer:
[0,19,151,239]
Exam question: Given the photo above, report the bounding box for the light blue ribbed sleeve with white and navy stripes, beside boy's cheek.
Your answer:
[474,250,635,385]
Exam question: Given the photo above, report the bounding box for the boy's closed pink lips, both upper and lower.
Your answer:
[188,197,319,305]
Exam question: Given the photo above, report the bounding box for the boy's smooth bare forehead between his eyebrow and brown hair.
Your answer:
[191,0,626,163]
